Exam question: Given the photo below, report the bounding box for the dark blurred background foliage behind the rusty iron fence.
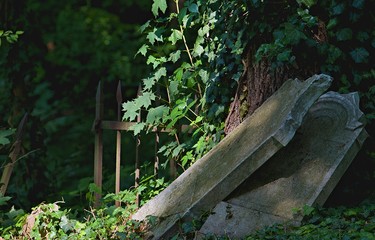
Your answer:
[0,0,151,209]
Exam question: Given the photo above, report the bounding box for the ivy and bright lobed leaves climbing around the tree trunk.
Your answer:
[123,0,375,179]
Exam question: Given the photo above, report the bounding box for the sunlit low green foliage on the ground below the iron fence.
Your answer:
[0,191,146,239]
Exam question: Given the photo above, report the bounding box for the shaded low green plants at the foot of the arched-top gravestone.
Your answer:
[246,204,375,240]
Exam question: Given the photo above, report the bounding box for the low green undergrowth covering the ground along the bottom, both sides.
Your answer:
[0,191,375,240]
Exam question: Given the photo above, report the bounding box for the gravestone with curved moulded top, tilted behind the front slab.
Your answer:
[200,92,367,237]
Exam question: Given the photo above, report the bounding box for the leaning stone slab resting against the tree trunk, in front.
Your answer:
[133,75,331,239]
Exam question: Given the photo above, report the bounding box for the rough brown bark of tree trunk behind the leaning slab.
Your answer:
[224,21,327,134]
